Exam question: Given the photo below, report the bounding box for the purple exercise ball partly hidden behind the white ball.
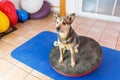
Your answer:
[30,1,51,19]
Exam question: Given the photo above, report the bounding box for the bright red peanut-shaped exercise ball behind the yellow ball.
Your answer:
[0,0,18,26]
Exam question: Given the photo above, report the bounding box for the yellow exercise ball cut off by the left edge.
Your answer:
[0,11,10,33]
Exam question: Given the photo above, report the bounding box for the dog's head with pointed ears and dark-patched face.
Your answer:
[54,13,75,37]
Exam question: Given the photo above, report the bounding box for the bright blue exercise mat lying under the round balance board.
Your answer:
[11,31,120,80]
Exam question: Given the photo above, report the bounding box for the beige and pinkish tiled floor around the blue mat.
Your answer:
[0,14,120,80]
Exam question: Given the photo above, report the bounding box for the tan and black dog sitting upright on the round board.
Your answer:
[54,13,80,67]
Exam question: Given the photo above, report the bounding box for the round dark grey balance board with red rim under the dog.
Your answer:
[50,36,102,77]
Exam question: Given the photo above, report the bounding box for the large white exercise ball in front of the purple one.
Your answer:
[20,0,43,13]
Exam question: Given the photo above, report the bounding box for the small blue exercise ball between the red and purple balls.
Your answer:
[17,10,29,22]
